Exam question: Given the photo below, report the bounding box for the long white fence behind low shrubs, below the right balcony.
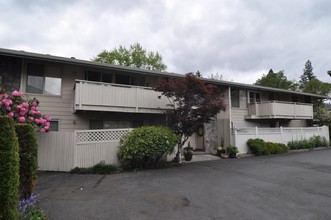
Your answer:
[231,126,329,153]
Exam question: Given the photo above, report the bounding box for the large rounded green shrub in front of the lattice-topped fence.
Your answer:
[118,126,179,168]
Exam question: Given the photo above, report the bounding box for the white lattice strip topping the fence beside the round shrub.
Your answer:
[76,129,132,144]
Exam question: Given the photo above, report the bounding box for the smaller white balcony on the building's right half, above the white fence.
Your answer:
[245,101,313,119]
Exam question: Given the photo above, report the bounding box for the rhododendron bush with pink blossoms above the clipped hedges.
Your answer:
[0,91,51,132]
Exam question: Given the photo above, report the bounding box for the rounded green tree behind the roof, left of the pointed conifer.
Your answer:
[254,69,297,90]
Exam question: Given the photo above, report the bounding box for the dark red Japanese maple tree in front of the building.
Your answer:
[154,72,226,162]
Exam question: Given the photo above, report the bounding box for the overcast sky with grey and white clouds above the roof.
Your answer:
[0,0,331,83]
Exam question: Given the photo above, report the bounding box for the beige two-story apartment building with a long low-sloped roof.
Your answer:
[0,49,329,169]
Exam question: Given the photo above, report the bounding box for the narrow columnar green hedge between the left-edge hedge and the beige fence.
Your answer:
[15,124,38,199]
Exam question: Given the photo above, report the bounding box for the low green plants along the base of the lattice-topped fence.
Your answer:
[70,163,120,174]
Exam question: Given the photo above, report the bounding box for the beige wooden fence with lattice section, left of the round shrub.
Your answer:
[38,129,132,171]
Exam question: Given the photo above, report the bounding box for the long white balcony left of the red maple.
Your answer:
[74,80,171,113]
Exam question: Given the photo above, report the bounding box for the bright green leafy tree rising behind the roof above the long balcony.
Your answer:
[93,43,167,71]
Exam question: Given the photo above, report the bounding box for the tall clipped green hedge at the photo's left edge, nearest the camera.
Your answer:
[0,117,19,220]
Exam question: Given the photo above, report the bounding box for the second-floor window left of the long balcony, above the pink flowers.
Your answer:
[26,63,62,95]
